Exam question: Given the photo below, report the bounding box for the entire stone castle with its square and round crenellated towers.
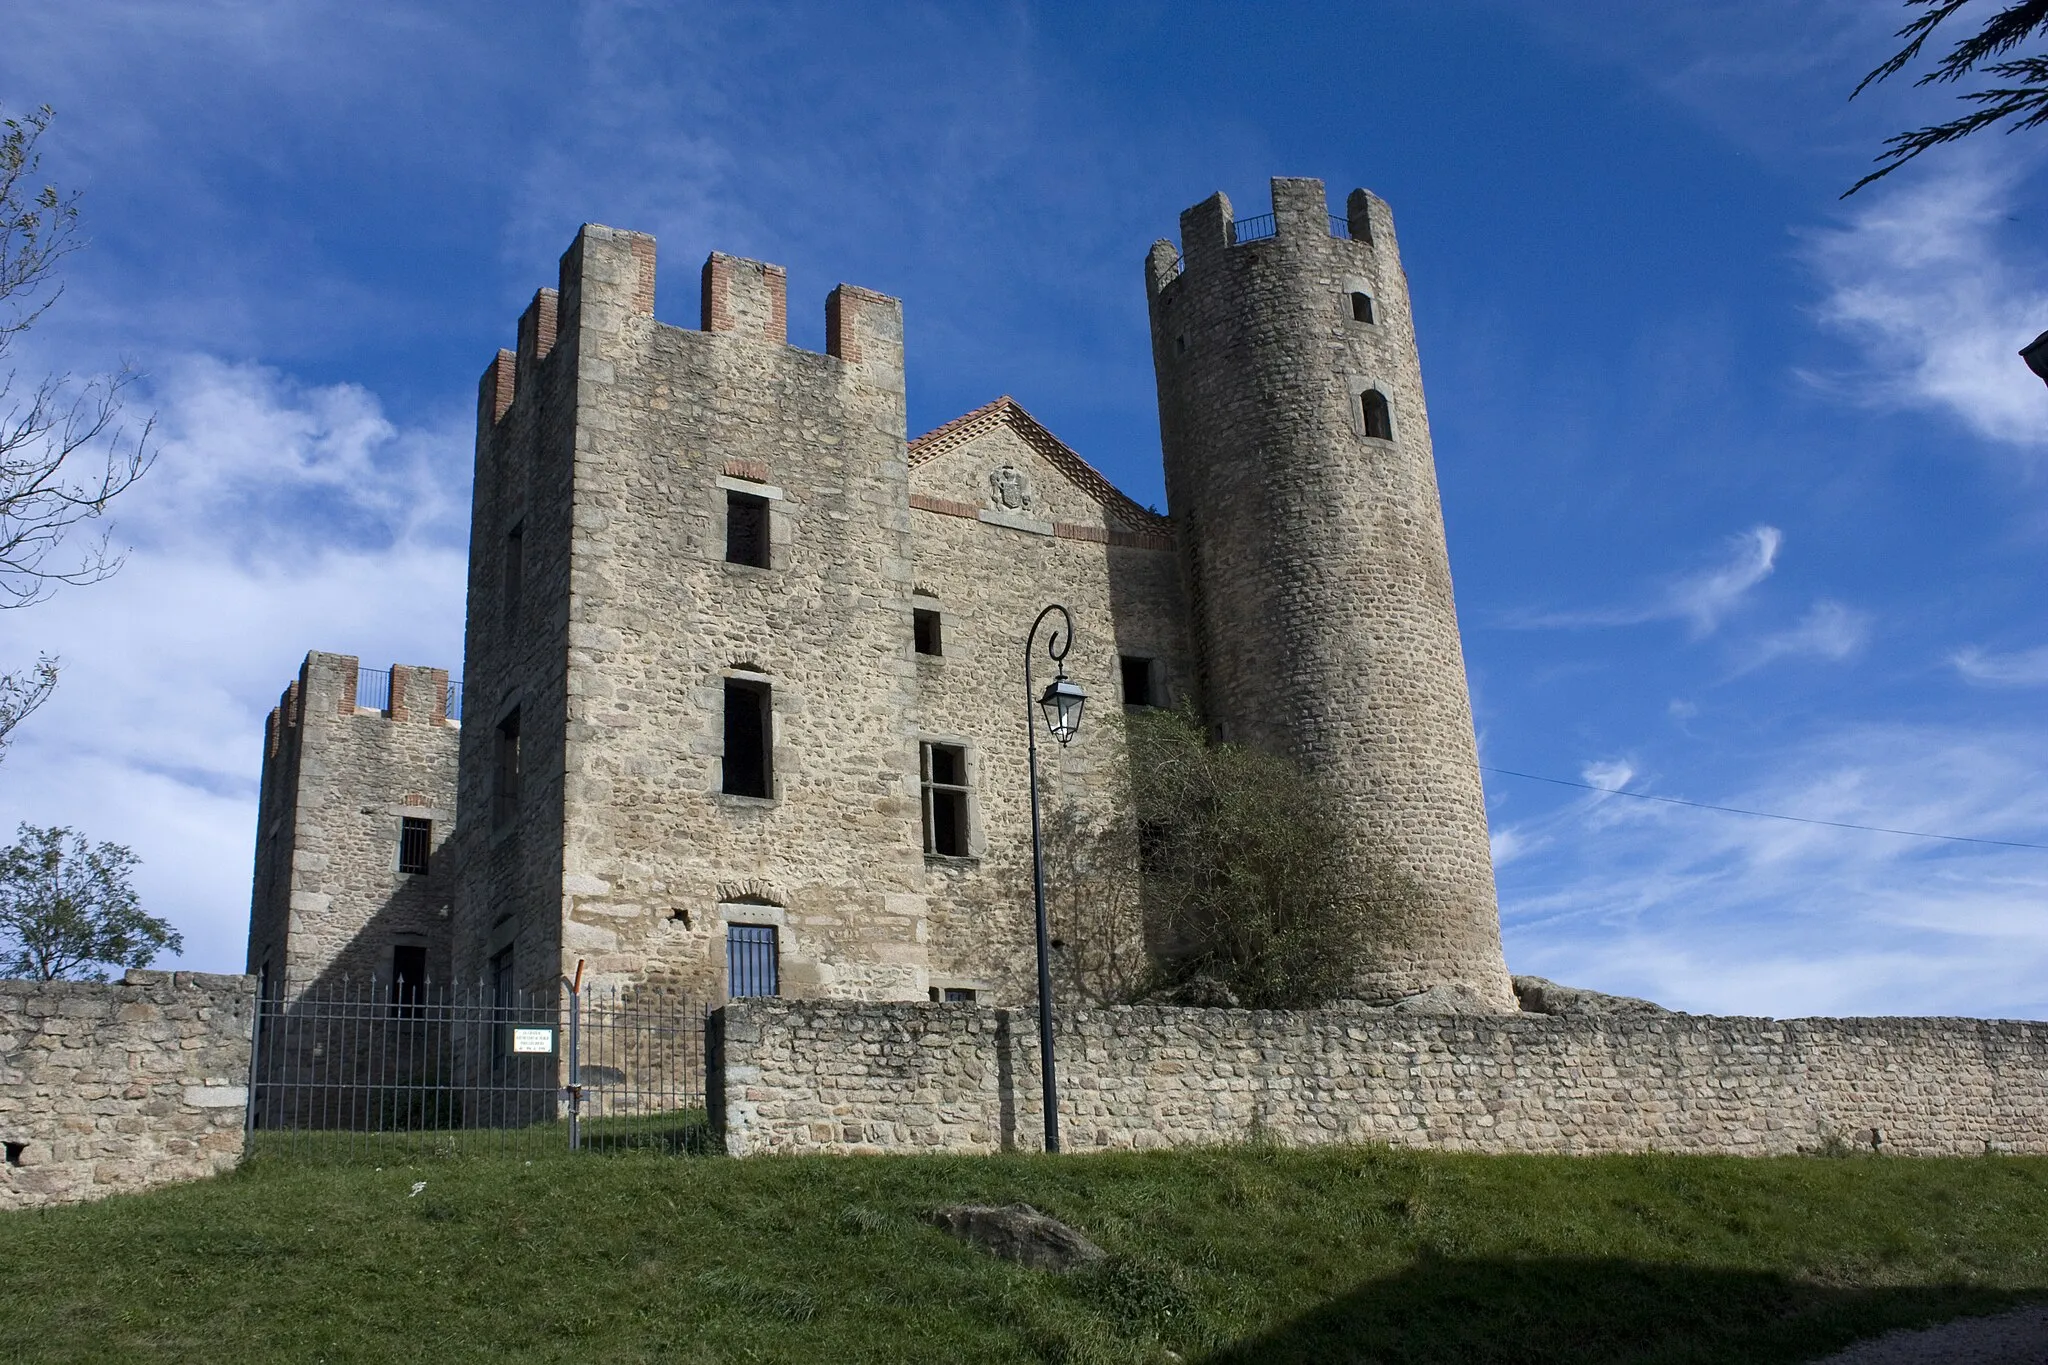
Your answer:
[248,178,1513,1011]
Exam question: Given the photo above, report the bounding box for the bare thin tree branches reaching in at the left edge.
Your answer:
[0,104,156,747]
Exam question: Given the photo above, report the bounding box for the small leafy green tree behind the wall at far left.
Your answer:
[0,825,184,980]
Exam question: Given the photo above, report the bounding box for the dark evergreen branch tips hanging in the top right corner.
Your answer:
[1843,0,2048,199]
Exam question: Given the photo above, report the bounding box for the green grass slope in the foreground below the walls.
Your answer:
[0,1148,2048,1365]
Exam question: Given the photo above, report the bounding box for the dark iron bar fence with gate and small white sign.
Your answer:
[248,980,705,1158]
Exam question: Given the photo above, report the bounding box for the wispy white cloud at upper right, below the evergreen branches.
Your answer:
[1806,154,2048,458]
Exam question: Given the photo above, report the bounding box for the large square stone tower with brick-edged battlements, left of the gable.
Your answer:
[455,225,928,999]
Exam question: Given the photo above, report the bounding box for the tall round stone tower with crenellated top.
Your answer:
[1145,178,1516,1011]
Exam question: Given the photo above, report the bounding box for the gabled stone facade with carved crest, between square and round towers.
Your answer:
[911,405,1192,1005]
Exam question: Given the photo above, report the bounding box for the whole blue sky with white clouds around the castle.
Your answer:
[0,0,2048,1017]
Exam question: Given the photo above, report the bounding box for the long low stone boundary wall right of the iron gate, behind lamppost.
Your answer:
[709,1001,2048,1156]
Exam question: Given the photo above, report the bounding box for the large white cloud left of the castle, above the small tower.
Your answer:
[0,356,467,970]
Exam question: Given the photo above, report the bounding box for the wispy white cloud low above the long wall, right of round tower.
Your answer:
[1501,724,2048,1017]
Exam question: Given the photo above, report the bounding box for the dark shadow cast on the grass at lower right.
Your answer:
[1202,1257,2028,1365]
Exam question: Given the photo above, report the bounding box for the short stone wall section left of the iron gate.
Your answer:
[0,972,256,1207]
